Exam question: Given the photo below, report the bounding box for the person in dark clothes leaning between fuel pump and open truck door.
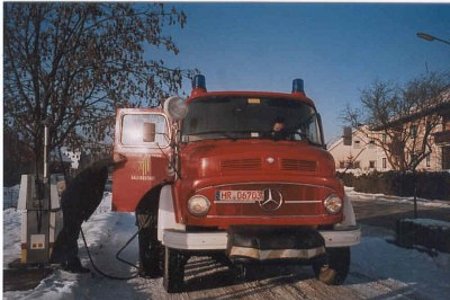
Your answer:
[50,155,125,273]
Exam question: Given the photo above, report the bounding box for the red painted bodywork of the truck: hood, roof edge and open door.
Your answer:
[113,88,344,228]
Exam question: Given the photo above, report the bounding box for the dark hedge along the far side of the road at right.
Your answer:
[337,171,450,201]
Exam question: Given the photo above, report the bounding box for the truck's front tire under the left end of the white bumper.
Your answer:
[163,247,186,293]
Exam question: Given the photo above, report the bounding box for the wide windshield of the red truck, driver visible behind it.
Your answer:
[181,97,322,145]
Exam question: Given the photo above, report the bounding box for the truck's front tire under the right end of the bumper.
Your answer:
[312,247,350,285]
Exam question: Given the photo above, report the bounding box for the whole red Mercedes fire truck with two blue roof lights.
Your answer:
[113,75,361,292]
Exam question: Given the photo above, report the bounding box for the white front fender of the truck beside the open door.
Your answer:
[158,185,186,241]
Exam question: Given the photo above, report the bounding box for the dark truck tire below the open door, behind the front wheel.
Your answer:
[138,215,164,278]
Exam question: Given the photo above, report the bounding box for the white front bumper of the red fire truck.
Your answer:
[162,225,361,255]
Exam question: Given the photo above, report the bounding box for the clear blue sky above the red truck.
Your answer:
[150,3,450,142]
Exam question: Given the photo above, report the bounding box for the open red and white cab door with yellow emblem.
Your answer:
[112,108,171,212]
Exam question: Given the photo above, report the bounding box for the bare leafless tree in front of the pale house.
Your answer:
[343,73,450,171]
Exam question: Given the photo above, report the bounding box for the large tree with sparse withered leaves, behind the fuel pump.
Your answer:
[4,2,197,178]
